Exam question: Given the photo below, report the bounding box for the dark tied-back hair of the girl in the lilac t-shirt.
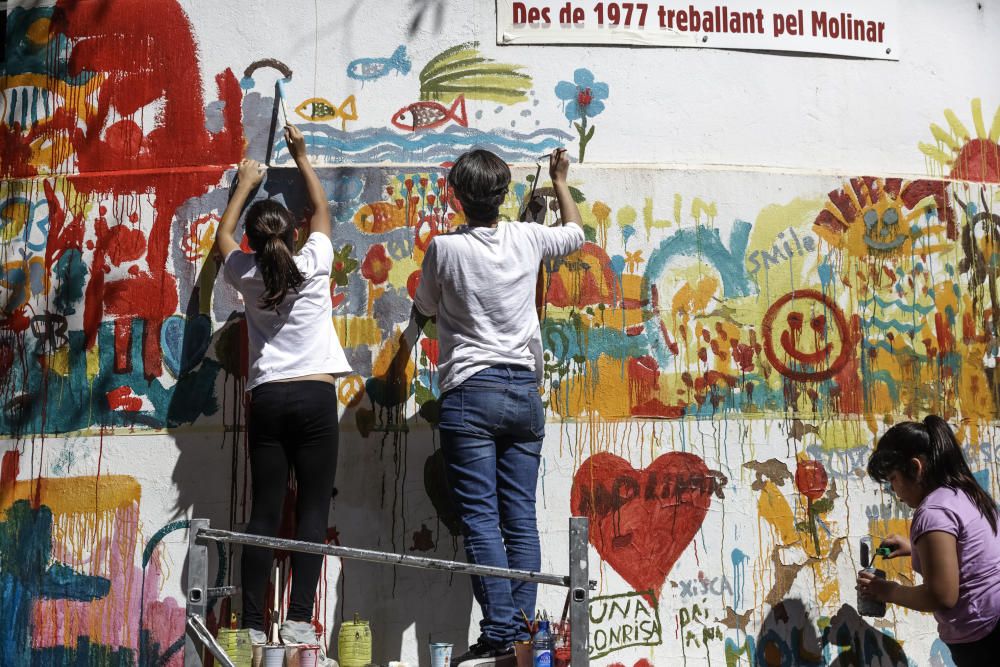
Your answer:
[868,415,998,534]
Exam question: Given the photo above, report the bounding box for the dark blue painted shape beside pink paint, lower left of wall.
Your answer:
[0,500,111,665]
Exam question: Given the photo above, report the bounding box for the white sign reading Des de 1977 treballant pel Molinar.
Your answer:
[497,0,899,60]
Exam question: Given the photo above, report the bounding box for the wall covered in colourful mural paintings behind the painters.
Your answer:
[0,0,1000,667]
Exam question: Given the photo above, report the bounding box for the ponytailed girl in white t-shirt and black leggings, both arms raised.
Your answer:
[216,125,351,665]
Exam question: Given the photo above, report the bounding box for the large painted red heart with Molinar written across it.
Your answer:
[570,452,727,597]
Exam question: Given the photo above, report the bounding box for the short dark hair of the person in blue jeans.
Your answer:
[448,149,510,225]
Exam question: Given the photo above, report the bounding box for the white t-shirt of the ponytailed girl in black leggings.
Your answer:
[223,232,351,391]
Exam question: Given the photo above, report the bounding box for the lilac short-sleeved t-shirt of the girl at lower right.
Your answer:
[910,486,1000,644]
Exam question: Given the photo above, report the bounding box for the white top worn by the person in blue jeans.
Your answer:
[413,220,584,393]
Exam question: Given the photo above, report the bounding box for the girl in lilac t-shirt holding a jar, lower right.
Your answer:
[858,415,1000,667]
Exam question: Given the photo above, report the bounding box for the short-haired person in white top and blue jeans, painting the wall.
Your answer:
[404,149,584,665]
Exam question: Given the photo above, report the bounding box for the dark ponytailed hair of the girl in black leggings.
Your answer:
[246,199,305,310]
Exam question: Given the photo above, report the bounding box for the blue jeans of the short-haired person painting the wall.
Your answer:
[439,366,545,647]
